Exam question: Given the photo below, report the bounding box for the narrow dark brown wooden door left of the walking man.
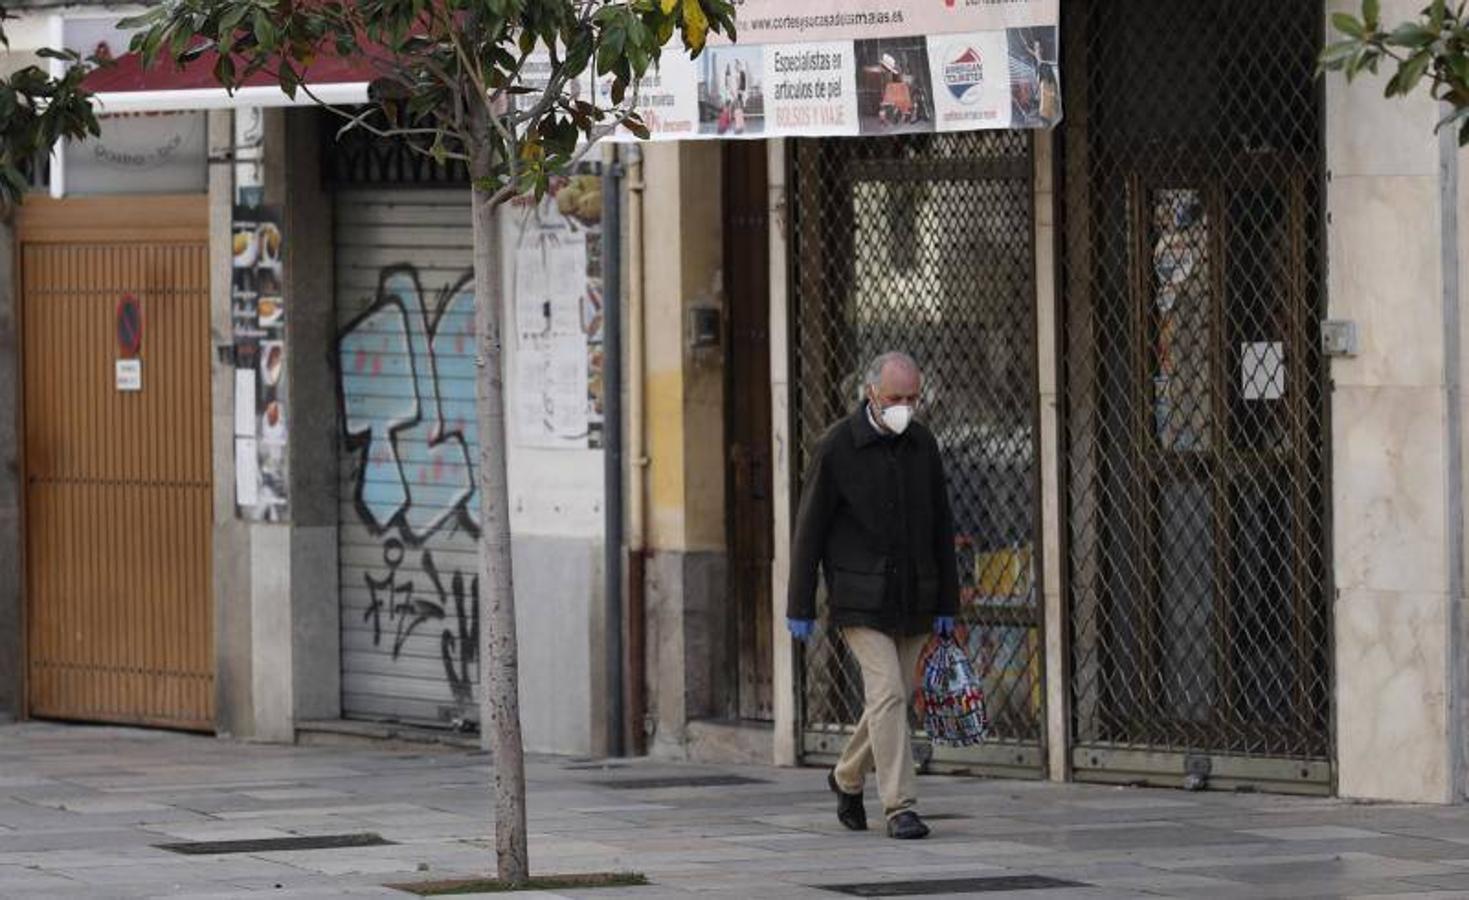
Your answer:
[724,141,774,719]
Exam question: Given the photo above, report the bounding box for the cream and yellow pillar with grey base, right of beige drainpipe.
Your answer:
[643,142,735,758]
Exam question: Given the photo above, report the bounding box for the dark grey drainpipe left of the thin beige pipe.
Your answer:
[602,145,626,756]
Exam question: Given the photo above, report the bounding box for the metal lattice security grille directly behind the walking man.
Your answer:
[790,132,1044,774]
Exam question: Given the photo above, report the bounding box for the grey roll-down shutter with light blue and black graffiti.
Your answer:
[335,188,479,725]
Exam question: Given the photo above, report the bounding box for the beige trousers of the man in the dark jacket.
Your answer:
[836,628,928,818]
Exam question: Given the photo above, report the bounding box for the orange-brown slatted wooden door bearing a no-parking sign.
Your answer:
[19,197,214,730]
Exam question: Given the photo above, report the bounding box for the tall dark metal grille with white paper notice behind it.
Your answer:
[1062,0,1331,790]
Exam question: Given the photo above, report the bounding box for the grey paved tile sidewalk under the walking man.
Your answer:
[0,724,1469,900]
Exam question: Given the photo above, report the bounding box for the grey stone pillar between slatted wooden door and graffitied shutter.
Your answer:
[210,109,341,741]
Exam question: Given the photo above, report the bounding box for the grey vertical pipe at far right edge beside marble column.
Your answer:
[1438,104,1469,803]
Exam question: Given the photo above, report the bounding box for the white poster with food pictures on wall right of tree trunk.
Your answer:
[505,166,602,449]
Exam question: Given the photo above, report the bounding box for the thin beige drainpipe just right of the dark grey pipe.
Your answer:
[624,144,648,756]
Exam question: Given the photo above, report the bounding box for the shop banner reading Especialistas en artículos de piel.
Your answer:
[598,0,1061,141]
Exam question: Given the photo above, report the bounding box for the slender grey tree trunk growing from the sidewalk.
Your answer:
[470,104,530,884]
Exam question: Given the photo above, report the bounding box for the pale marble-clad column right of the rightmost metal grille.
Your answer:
[1327,0,1463,803]
